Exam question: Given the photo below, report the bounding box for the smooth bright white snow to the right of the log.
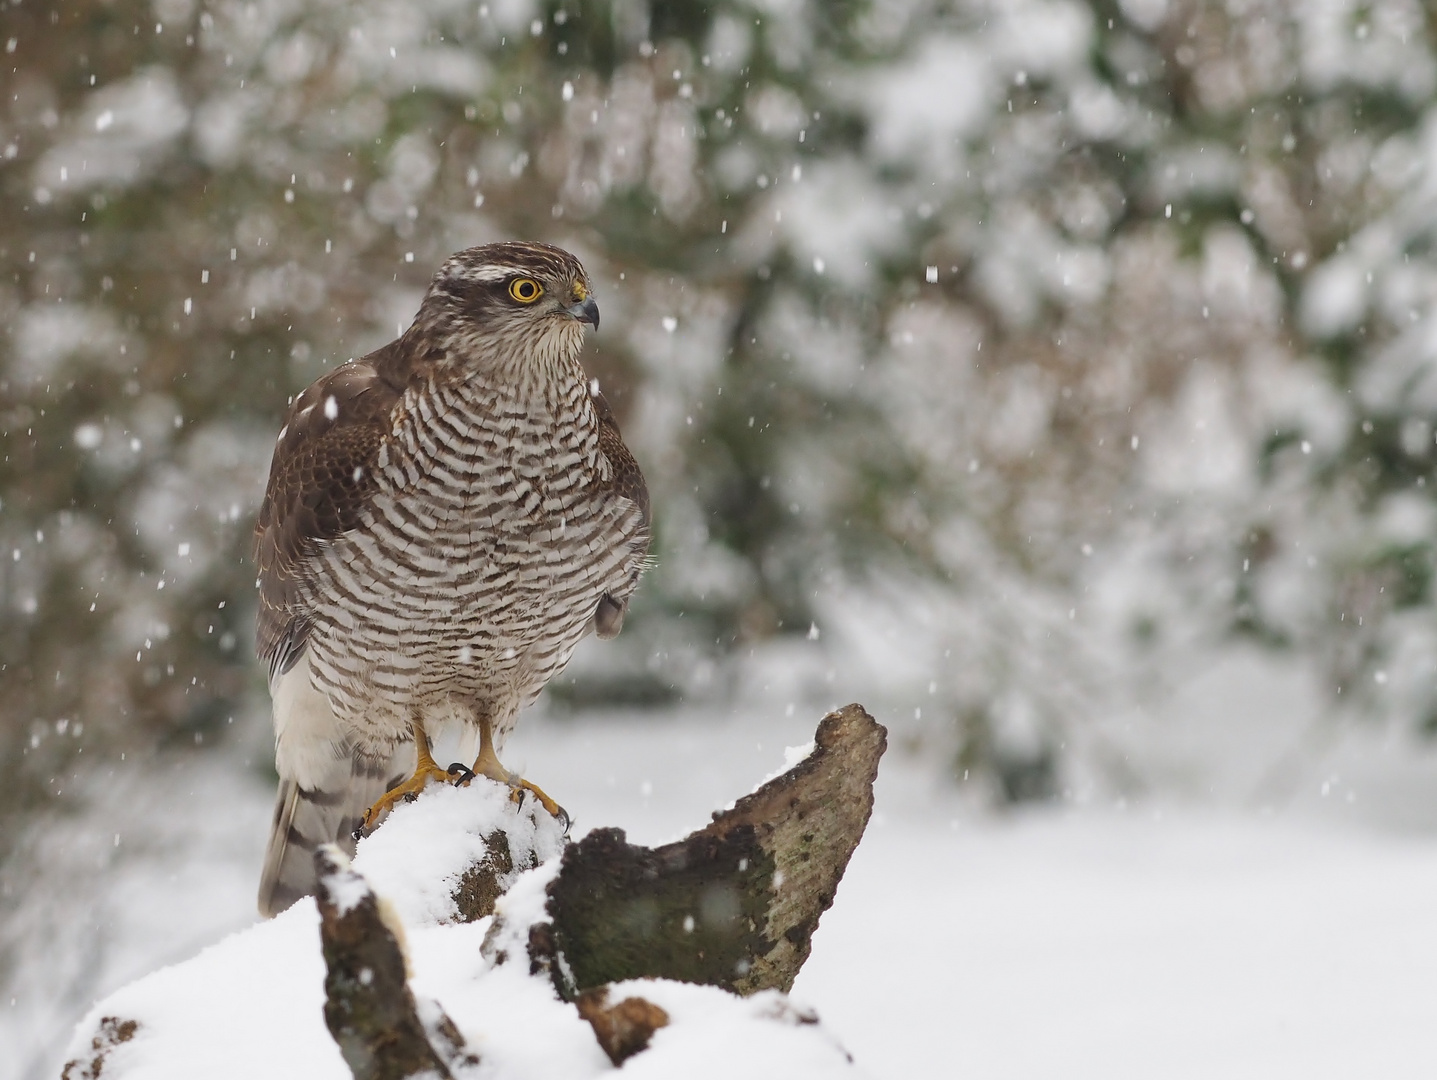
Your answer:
[795,813,1437,1080]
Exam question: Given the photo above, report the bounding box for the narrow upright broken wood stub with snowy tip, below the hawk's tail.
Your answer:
[315,844,479,1080]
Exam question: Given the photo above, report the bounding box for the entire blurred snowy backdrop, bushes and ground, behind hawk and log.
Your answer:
[8,0,1437,1080]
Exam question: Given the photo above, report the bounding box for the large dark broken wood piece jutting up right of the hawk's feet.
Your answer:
[530,705,887,998]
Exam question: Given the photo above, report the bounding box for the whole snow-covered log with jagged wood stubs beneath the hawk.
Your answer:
[66,705,887,1080]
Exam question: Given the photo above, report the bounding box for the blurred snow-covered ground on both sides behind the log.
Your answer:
[16,654,1437,1080]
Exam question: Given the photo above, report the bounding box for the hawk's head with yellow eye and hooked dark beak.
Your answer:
[415,241,599,368]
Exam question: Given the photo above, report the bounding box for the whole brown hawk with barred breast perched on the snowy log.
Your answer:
[256,243,648,913]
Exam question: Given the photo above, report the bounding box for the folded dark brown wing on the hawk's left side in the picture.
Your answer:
[254,350,399,681]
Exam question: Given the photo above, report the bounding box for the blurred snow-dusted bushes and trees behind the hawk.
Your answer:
[0,0,1437,1045]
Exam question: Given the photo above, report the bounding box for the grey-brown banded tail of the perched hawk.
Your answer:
[259,754,405,918]
